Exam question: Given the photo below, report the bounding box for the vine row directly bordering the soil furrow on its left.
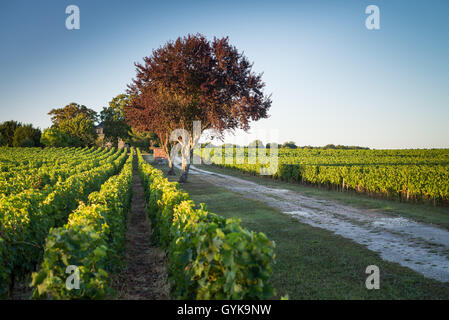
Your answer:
[32,152,133,299]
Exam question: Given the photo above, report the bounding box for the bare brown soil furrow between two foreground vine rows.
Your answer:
[117,163,169,300]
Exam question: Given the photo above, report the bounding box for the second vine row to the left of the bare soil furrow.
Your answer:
[0,150,126,295]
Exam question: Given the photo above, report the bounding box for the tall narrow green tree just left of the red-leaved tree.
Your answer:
[100,94,131,146]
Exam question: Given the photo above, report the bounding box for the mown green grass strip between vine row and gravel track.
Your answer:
[150,160,449,299]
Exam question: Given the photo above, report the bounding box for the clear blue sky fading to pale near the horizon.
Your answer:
[0,0,449,148]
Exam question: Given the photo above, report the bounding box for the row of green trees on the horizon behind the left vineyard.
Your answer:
[0,94,158,149]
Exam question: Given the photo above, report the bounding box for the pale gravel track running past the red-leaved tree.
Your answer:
[180,165,449,282]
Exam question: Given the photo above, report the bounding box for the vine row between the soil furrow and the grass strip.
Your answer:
[138,150,275,299]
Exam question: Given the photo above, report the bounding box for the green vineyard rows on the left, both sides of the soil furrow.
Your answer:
[0,148,275,299]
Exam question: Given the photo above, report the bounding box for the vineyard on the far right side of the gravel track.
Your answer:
[201,148,449,204]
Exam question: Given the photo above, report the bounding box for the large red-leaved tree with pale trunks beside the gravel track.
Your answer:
[125,34,271,182]
